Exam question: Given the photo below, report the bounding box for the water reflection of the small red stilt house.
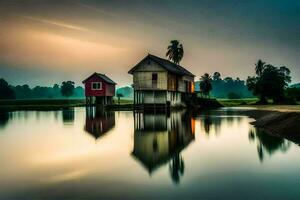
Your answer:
[84,107,115,140]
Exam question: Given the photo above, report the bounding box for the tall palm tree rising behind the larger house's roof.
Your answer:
[166,40,184,65]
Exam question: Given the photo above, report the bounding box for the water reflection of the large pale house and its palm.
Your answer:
[132,112,195,183]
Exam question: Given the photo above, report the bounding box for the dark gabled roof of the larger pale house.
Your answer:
[128,54,195,76]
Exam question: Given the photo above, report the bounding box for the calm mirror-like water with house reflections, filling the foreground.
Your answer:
[0,108,300,200]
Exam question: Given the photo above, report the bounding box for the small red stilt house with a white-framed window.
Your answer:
[82,72,116,105]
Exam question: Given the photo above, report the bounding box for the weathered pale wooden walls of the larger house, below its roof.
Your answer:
[133,56,194,106]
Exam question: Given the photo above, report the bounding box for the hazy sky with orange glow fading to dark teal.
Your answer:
[0,0,300,87]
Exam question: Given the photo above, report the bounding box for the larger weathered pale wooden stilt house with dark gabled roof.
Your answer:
[128,54,195,106]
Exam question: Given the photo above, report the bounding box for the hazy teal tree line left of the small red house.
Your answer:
[0,78,84,99]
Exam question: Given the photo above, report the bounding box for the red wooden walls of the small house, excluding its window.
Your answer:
[84,76,115,97]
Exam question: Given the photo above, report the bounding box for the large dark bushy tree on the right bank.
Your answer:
[247,61,291,104]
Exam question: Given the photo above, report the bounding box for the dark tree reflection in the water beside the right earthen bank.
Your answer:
[248,128,291,162]
